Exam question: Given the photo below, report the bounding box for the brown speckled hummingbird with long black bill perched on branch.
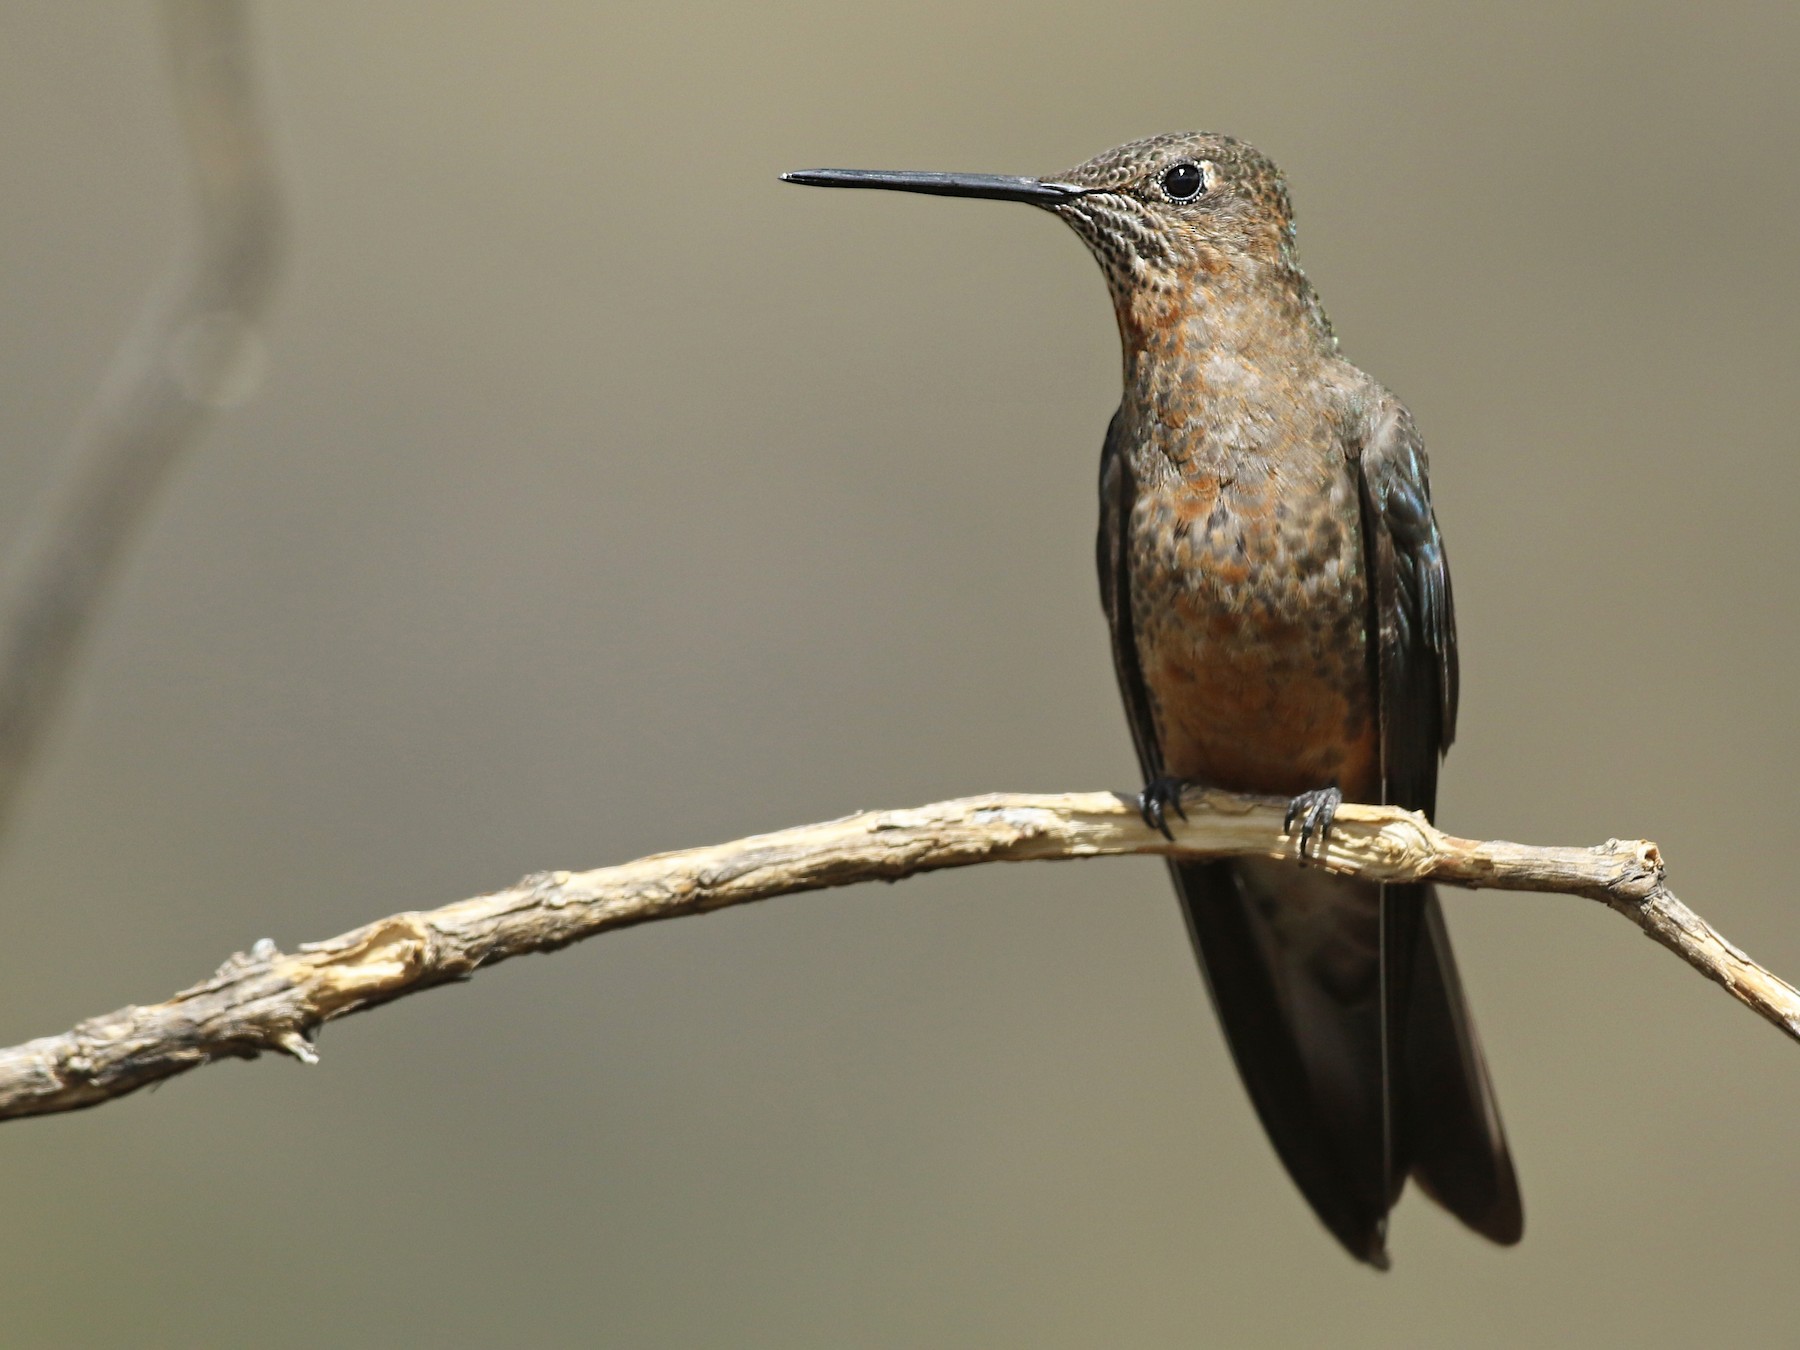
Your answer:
[783,131,1523,1269]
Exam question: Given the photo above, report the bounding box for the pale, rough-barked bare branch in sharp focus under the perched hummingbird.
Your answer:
[0,792,1800,1120]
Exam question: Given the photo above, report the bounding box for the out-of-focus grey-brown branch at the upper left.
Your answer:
[0,0,281,824]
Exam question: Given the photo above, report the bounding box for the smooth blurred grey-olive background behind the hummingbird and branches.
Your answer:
[0,0,1800,1346]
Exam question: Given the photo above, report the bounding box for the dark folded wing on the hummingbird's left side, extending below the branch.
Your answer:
[1096,416,1388,1265]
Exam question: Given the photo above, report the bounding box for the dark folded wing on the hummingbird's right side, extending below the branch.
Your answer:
[1357,398,1525,1242]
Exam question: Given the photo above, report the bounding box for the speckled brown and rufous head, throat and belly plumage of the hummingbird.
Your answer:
[1057,135,1384,797]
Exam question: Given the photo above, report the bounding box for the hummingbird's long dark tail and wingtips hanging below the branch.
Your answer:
[1170,862,1525,1269]
